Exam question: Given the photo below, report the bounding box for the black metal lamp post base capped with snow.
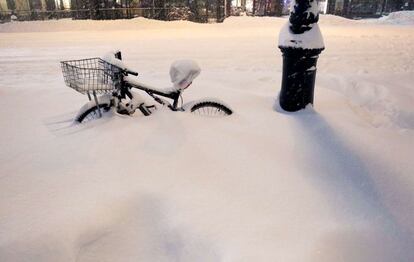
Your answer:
[279,0,325,112]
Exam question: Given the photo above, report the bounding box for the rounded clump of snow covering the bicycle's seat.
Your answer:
[170,60,201,90]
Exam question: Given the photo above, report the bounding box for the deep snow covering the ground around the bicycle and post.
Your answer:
[0,12,414,262]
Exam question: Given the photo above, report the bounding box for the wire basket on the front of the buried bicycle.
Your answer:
[60,58,122,96]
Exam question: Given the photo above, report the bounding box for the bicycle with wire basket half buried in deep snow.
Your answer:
[60,51,233,123]
